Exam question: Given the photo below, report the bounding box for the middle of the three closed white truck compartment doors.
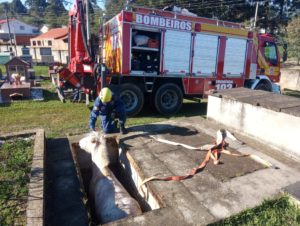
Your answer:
[192,34,219,77]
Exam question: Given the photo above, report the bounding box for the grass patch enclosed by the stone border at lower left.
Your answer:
[0,139,33,225]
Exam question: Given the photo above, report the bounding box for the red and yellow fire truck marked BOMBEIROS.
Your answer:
[60,2,280,115]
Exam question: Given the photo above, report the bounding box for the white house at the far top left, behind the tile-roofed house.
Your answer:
[0,18,39,35]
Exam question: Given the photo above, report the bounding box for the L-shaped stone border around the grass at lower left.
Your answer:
[0,129,45,226]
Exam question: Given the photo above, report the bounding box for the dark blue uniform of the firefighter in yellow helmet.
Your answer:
[89,95,126,133]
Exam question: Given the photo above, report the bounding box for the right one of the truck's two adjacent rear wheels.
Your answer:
[155,83,182,115]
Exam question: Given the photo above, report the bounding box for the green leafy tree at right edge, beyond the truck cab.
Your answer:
[287,16,300,65]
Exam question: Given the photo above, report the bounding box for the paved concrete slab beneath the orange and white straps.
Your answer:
[111,117,300,225]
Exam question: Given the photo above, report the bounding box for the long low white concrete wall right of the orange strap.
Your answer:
[207,90,300,159]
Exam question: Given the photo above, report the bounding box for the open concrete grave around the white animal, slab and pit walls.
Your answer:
[59,117,300,225]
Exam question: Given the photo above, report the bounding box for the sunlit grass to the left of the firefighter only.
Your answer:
[0,96,89,137]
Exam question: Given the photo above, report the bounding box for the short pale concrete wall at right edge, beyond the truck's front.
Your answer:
[280,68,300,91]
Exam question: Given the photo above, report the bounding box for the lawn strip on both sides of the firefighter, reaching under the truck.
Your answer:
[0,90,206,138]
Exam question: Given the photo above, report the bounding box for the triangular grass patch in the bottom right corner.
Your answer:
[210,196,300,226]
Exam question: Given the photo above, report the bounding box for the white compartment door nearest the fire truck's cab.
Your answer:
[223,38,247,78]
